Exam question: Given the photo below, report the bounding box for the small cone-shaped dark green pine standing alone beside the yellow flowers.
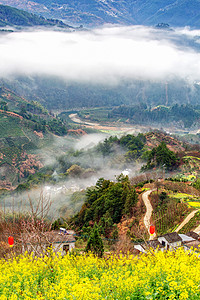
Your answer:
[85,222,104,257]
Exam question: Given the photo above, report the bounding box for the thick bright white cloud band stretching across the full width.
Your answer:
[0,26,200,84]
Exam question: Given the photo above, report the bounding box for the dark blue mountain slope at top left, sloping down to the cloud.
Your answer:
[0,5,70,28]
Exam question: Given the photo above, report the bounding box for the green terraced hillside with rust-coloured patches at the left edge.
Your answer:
[0,88,71,188]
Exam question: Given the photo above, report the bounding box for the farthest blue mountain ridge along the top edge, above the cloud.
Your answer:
[0,0,200,27]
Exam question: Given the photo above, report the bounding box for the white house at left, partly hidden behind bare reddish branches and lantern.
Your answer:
[22,229,76,256]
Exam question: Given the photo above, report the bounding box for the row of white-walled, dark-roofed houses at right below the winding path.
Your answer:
[134,231,200,253]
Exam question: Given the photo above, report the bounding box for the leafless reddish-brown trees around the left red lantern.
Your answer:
[0,191,52,257]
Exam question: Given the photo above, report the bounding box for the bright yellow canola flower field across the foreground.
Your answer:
[0,249,200,300]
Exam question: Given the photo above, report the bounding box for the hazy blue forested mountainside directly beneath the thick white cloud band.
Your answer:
[0,76,200,111]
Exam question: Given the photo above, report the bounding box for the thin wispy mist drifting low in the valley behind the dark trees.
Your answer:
[5,133,142,219]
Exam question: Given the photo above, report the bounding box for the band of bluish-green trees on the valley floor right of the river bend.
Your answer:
[108,103,200,127]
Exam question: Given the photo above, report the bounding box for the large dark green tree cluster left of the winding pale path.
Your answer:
[71,175,138,237]
